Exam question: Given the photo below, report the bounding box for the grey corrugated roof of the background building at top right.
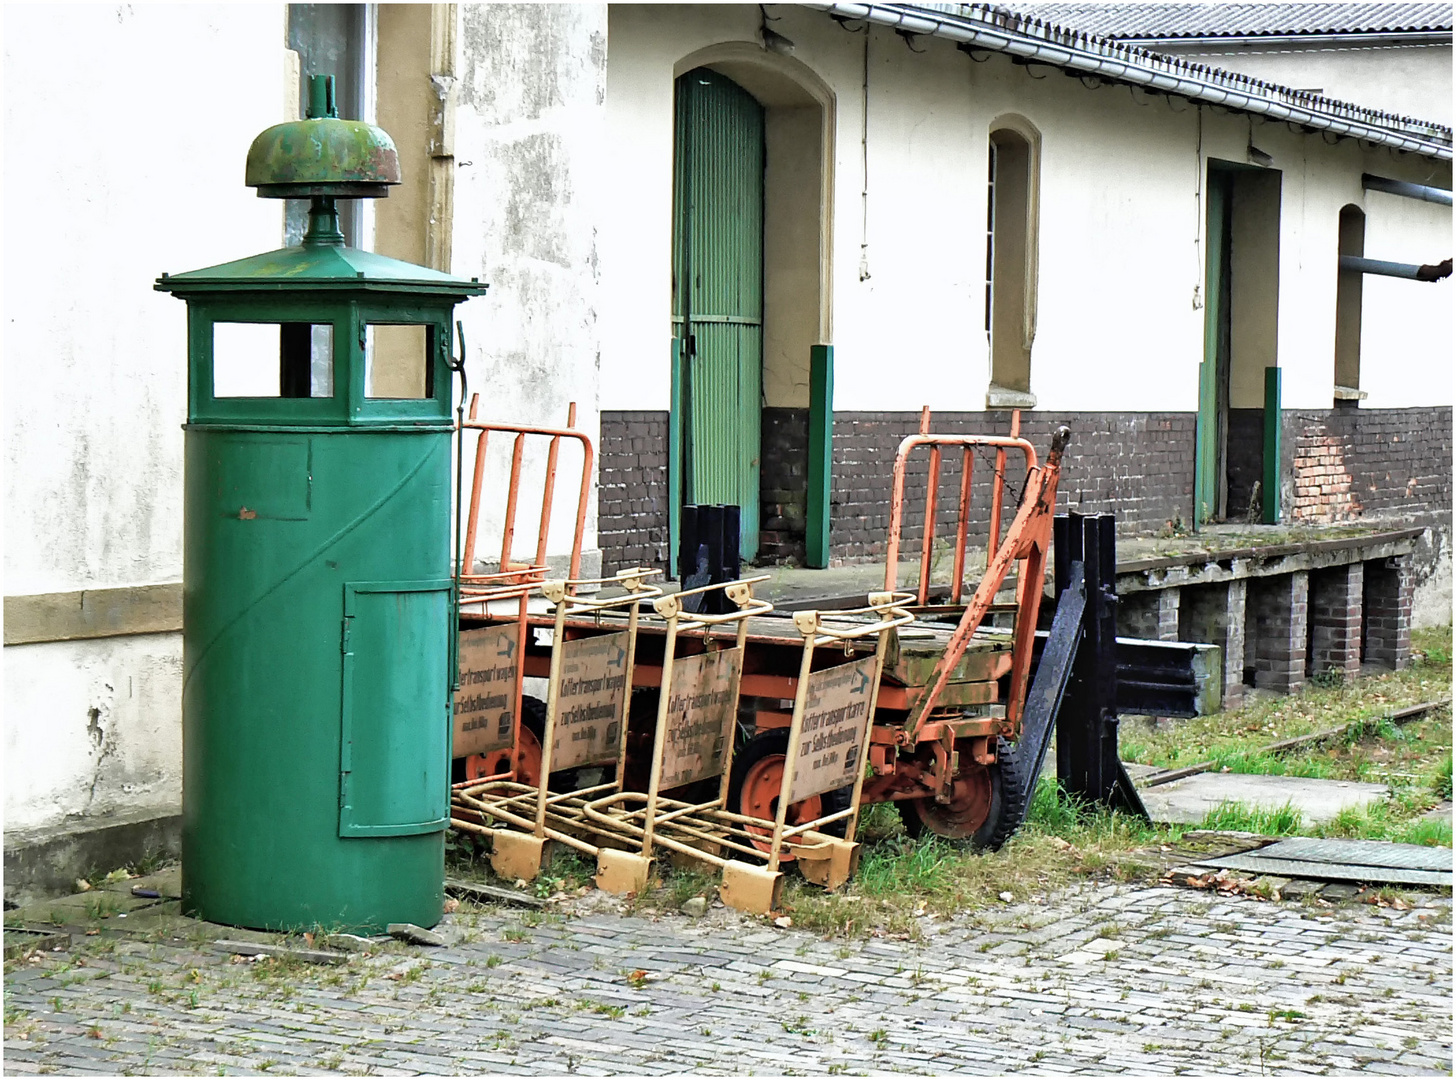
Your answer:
[1005,1,1452,41]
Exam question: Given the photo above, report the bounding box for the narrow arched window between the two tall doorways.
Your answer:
[986,118,1041,409]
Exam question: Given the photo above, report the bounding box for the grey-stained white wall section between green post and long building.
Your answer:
[453,4,612,569]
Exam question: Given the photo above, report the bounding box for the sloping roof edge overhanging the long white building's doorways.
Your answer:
[805,0,1452,162]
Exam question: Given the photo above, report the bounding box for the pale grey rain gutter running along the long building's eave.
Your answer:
[805,0,1452,162]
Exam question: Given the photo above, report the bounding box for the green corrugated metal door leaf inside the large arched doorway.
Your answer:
[673,67,763,559]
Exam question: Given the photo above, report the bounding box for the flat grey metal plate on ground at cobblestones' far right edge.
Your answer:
[1200,837,1452,888]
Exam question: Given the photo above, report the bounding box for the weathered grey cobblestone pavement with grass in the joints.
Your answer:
[4,885,1452,1076]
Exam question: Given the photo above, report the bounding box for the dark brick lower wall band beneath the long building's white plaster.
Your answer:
[598,408,1452,590]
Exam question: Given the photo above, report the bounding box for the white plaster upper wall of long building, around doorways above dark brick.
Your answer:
[601,4,1452,422]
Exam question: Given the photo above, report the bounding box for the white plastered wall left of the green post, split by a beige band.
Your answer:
[3,4,287,846]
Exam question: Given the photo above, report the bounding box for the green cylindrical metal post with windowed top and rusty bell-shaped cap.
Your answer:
[156,79,486,932]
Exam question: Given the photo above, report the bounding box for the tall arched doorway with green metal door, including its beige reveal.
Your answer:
[668,41,834,565]
